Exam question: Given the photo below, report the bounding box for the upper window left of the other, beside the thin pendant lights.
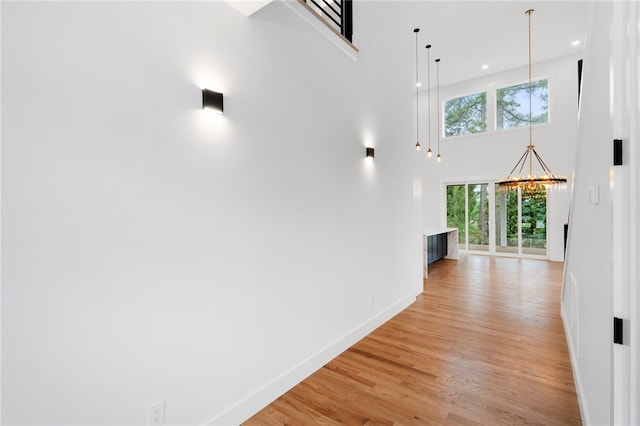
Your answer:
[444,92,487,137]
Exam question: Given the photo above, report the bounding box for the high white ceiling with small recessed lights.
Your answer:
[397,0,588,85]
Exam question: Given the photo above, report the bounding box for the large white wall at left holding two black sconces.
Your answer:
[2,2,422,425]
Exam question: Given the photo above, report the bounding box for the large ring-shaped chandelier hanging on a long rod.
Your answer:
[497,9,567,193]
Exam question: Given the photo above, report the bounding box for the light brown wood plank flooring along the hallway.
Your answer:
[245,255,581,426]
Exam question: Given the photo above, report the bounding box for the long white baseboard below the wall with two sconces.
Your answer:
[207,294,417,426]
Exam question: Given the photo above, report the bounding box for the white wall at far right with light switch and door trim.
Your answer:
[562,2,640,425]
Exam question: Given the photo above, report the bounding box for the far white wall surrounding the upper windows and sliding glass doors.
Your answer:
[420,55,581,260]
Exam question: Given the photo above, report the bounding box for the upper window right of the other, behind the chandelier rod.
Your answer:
[496,79,549,129]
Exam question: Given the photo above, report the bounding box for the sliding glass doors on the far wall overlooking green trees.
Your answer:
[446,182,547,256]
